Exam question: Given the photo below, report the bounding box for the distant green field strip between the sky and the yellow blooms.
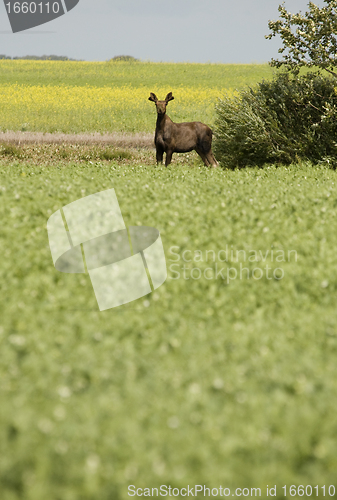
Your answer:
[0,59,274,88]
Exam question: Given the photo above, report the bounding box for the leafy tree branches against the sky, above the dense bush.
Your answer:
[265,0,337,78]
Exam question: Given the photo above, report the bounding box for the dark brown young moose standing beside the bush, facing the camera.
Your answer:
[149,92,218,167]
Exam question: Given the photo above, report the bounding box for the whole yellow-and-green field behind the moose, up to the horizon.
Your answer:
[0,60,273,134]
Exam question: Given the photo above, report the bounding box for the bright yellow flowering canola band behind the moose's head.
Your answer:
[0,84,234,132]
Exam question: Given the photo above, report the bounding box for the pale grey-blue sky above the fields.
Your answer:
[0,0,324,63]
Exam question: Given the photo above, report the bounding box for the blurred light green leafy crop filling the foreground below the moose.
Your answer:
[0,153,337,500]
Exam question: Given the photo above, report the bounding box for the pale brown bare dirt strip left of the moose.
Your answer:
[0,131,154,148]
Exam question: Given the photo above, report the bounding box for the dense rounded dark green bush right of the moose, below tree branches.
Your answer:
[214,73,337,168]
